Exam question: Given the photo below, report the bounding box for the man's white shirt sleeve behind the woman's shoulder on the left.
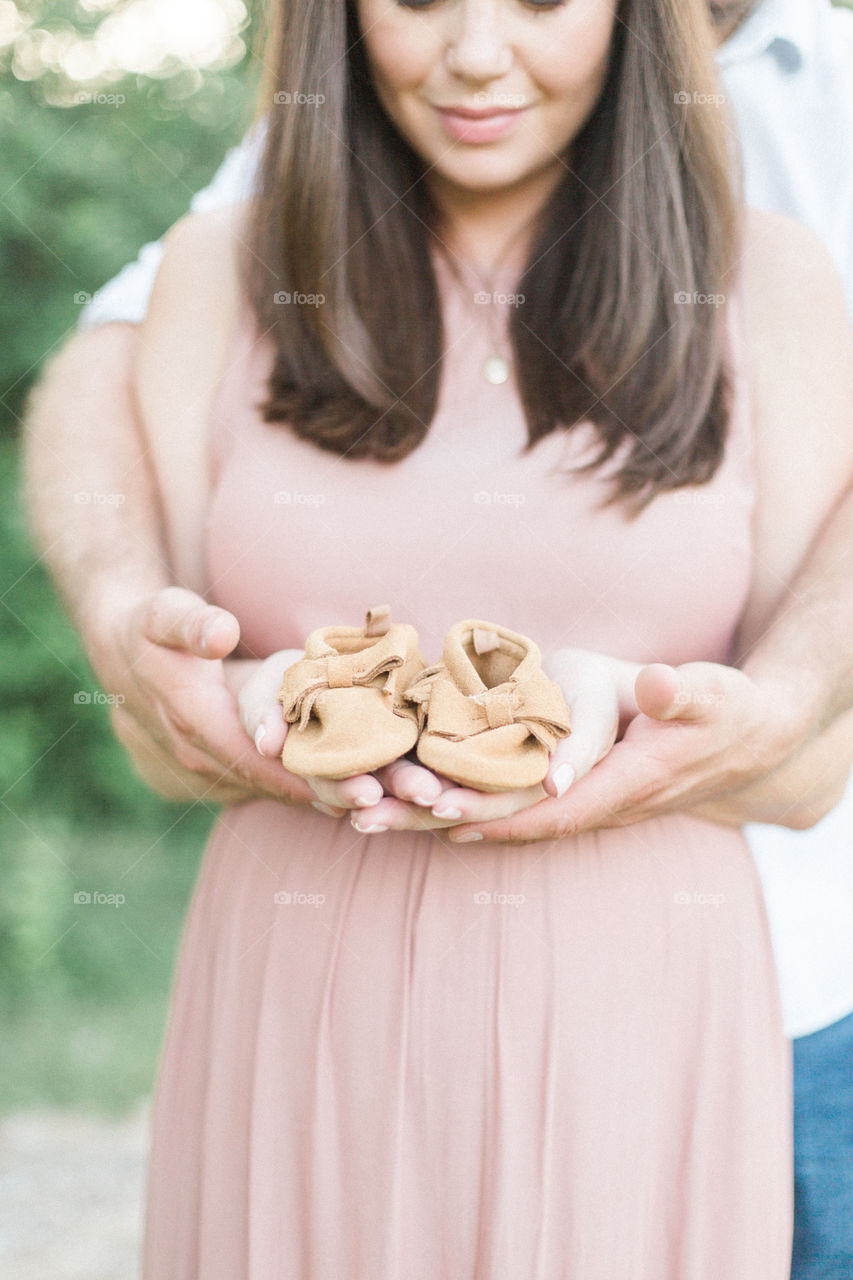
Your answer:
[78,124,264,329]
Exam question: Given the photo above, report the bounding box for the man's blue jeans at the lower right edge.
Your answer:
[792,1014,853,1280]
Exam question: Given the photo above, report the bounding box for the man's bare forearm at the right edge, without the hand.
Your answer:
[738,486,853,737]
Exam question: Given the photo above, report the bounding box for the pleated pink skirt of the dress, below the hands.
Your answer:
[143,800,793,1280]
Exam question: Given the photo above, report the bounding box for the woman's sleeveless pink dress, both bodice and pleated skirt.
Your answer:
[145,252,793,1280]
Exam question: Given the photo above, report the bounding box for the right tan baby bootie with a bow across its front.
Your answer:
[405,620,570,791]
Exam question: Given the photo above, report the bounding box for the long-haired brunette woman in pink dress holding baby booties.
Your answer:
[129,0,853,1280]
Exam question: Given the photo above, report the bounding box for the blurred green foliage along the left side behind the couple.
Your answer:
[0,0,256,1108]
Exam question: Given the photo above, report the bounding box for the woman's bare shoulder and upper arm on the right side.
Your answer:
[727,210,853,641]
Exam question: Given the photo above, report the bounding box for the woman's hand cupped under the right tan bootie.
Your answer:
[351,649,630,838]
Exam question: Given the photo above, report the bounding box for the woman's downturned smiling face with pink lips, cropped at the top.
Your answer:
[357,0,617,193]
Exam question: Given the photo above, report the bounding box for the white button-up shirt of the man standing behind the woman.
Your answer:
[81,0,853,1036]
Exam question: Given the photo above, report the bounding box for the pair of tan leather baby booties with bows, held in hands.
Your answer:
[278,605,570,791]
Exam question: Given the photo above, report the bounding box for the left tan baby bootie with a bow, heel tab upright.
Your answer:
[278,604,427,778]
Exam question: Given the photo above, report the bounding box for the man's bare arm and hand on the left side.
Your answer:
[24,318,307,801]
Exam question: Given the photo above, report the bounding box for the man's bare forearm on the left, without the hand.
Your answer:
[24,324,170,652]
